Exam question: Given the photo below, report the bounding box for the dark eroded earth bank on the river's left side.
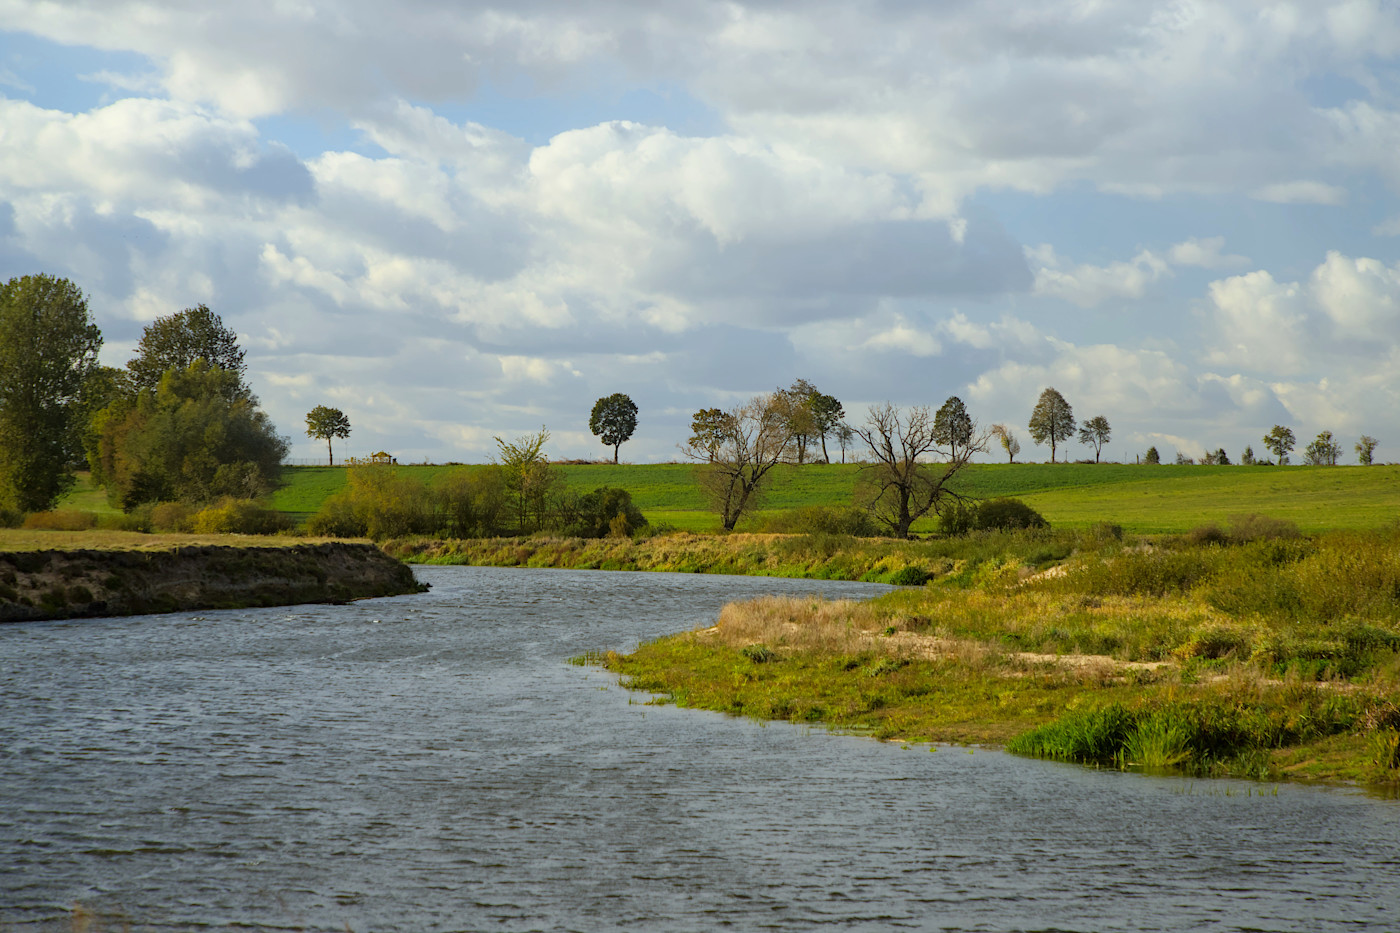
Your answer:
[0,542,424,622]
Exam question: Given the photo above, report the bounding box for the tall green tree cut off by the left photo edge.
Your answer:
[0,275,102,511]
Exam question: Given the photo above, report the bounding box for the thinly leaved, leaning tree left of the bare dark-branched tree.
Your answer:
[680,392,794,531]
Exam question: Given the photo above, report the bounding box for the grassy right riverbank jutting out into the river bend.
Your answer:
[603,521,1400,783]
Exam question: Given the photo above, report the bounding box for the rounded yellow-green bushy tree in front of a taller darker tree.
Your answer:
[90,359,287,510]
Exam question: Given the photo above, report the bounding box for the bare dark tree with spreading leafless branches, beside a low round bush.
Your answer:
[855,402,988,538]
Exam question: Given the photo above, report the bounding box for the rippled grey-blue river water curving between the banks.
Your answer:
[0,567,1400,933]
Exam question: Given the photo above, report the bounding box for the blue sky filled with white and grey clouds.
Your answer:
[0,0,1400,462]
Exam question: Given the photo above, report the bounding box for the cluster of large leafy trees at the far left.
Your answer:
[0,268,287,511]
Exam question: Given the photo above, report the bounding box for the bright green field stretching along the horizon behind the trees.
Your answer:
[264,464,1400,534]
